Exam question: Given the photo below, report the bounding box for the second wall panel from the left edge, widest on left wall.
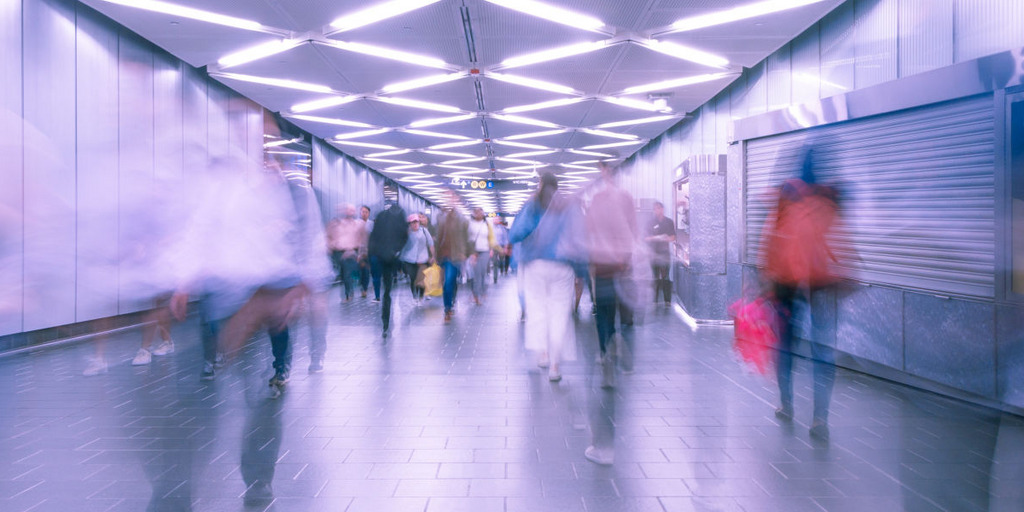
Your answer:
[22,0,76,331]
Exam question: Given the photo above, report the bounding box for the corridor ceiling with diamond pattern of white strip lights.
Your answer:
[82,0,843,212]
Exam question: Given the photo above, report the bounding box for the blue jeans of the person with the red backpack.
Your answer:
[775,285,836,423]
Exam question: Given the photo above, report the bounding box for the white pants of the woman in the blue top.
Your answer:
[519,260,575,365]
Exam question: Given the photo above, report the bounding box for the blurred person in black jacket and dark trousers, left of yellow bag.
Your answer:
[369,203,409,339]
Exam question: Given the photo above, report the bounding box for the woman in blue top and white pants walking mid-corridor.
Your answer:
[509,173,586,382]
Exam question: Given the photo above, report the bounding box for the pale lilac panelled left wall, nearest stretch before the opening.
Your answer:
[0,0,263,344]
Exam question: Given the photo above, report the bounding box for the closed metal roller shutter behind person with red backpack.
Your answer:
[744,95,995,298]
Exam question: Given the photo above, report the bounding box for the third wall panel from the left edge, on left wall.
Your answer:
[75,9,119,322]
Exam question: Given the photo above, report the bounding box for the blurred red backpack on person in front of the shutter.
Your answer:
[765,179,839,287]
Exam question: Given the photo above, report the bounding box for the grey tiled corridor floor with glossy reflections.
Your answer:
[0,280,1024,512]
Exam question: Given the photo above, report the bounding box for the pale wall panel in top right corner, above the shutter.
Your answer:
[953,0,1024,62]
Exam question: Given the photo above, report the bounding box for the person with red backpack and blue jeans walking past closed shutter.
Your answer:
[763,151,839,440]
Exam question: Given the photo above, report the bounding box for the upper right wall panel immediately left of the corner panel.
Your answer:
[898,0,954,77]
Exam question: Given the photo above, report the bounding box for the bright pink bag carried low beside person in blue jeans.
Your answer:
[729,297,778,375]
